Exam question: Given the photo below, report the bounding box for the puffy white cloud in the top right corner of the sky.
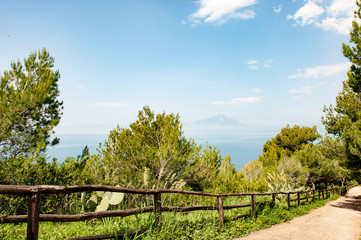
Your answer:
[287,0,356,34]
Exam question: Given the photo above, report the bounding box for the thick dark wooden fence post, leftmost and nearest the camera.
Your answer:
[26,190,40,240]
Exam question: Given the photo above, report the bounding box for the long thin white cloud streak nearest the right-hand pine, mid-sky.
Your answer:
[288,62,351,78]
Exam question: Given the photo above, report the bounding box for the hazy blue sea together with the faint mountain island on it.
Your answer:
[47,115,279,170]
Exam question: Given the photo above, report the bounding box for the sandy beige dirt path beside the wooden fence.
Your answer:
[233,187,361,240]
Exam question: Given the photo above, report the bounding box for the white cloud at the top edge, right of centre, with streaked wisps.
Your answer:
[189,0,257,24]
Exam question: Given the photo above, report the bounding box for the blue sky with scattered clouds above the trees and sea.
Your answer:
[0,0,355,134]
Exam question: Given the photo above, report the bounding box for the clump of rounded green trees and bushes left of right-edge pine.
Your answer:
[242,125,349,191]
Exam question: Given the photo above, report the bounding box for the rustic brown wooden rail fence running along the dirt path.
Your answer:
[0,185,346,240]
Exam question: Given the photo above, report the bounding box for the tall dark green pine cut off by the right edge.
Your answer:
[322,0,361,180]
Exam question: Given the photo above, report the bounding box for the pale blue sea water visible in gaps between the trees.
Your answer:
[47,134,274,170]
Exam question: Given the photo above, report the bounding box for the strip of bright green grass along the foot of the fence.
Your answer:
[0,195,338,240]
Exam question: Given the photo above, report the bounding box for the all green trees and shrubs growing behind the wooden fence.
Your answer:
[0,1,361,238]
